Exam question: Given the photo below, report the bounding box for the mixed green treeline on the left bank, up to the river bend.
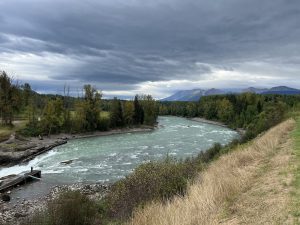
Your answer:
[0,72,158,136]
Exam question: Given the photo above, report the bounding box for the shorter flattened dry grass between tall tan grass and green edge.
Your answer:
[218,132,293,225]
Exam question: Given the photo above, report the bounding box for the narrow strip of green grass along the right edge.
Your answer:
[291,116,300,224]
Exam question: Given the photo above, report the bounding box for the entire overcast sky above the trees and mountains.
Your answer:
[0,0,300,99]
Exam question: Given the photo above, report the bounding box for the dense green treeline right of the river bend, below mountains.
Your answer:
[159,93,300,140]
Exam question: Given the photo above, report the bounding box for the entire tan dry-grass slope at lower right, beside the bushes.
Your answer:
[129,120,300,225]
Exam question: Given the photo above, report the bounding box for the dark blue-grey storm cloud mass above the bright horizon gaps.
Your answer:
[0,0,300,96]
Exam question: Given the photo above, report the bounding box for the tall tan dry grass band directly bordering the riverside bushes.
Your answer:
[128,120,295,225]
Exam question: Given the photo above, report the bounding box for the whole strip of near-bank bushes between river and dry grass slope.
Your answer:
[19,141,238,225]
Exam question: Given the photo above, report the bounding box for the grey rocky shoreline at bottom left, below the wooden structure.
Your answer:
[0,183,109,225]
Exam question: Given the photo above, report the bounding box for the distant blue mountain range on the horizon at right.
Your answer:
[161,86,300,101]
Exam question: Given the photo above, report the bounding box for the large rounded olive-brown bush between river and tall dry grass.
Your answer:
[104,157,204,219]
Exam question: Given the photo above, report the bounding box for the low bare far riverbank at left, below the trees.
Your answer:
[0,126,156,169]
